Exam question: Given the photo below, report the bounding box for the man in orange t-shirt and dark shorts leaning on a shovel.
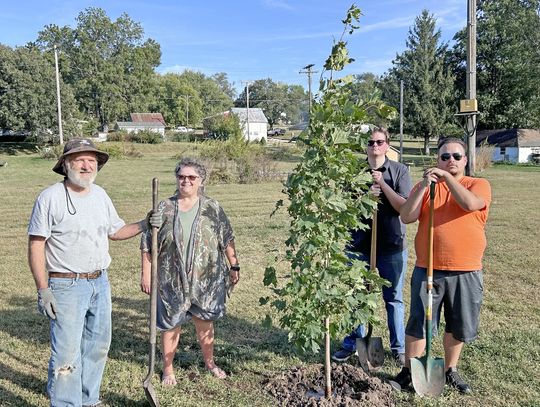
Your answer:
[390,138,491,394]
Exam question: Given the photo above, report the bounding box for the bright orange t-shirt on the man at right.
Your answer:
[414,176,491,271]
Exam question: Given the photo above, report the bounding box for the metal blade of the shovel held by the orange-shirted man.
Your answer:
[411,356,446,397]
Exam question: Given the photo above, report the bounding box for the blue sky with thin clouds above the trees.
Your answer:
[0,0,467,93]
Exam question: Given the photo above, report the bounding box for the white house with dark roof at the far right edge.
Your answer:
[476,129,540,163]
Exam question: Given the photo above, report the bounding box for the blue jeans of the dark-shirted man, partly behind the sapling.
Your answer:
[341,250,407,353]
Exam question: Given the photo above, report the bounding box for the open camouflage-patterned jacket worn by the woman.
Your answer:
[141,196,234,330]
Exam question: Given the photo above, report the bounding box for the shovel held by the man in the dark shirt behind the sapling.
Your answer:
[356,208,384,372]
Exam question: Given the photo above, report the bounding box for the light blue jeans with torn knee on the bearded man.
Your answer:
[47,272,111,407]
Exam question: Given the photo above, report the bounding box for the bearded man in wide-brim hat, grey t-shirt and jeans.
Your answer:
[28,139,161,406]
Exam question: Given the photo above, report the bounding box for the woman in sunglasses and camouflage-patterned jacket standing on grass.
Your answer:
[141,158,240,385]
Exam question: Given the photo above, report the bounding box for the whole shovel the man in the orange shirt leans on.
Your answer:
[411,182,446,397]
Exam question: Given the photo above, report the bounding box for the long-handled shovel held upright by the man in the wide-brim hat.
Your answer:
[143,178,159,407]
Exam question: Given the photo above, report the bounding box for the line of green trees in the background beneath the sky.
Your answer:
[0,0,540,144]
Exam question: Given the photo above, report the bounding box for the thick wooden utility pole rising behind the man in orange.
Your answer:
[466,0,476,176]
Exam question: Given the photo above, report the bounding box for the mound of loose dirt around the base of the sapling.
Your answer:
[263,363,395,407]
